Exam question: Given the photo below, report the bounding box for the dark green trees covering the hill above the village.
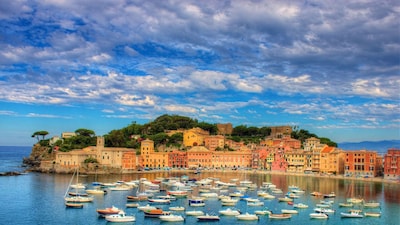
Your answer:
[32,114,337,151]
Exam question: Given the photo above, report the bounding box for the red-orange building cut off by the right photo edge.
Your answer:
[383,148,400,180]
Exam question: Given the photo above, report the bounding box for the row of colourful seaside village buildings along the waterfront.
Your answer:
[41,123,400,180]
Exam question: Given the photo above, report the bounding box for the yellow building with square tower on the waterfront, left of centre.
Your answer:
[140,139,168,168]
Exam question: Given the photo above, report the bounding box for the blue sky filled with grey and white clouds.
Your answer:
[0,0,400,145]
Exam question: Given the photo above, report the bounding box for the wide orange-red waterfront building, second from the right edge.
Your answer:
[344,150,379,177]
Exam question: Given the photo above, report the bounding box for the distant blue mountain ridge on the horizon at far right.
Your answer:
[338,140,400,154]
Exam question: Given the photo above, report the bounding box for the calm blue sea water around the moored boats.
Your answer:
[0,146,400,225]
